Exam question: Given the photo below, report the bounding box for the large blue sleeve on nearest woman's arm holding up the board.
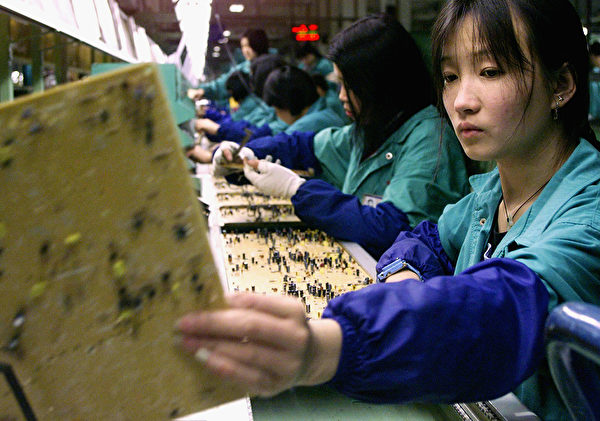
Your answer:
[323,259,548,403]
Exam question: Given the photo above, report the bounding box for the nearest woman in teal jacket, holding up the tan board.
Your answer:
[178,0,600,421]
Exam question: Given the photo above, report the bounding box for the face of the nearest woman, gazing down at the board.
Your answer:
[441,17,554,161]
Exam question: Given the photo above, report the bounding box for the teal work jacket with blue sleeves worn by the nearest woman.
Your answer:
[323,139,600,421]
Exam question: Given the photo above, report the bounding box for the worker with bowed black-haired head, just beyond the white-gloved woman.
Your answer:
[196,66,344,144]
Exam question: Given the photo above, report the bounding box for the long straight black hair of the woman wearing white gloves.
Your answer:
[329,15,434,159]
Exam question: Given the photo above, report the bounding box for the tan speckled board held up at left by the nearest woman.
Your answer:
[0,65,242,420]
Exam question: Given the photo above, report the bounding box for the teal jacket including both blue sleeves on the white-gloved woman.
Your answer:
[247,106,468,258]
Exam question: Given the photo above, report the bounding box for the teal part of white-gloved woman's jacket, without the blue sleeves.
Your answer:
[314,105,469,226]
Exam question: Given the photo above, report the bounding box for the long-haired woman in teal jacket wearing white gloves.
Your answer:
[213,16,468,257]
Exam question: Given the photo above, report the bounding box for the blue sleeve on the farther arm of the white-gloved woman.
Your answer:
[246,132,321,173]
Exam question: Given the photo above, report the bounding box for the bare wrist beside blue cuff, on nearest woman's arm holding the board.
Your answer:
[297,319,342,386]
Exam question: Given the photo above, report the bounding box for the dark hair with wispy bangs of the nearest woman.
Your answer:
[432,0,598,151]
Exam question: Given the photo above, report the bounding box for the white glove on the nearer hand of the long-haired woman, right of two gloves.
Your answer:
[244,159,306,199]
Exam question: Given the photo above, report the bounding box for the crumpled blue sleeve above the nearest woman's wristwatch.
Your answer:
[376,221,454,279]
